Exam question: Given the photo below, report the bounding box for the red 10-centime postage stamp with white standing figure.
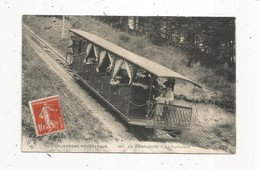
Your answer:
[29,96,65,136]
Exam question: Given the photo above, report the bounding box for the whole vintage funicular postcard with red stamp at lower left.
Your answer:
[21,15,236,154]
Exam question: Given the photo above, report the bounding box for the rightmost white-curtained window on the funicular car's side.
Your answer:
[110,59,133,85]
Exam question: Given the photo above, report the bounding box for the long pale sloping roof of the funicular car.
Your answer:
[70,29,201,87]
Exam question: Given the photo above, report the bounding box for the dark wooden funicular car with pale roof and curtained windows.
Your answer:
[67,29,201,137]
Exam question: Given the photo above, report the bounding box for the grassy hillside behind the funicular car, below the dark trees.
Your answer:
[23,16,236,153]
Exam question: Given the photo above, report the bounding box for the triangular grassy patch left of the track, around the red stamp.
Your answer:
[22,35,108,144]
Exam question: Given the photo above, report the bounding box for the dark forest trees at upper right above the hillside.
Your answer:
[95,16,235,82]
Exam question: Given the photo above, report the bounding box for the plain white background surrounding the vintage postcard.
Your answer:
[0,0,260,170]
